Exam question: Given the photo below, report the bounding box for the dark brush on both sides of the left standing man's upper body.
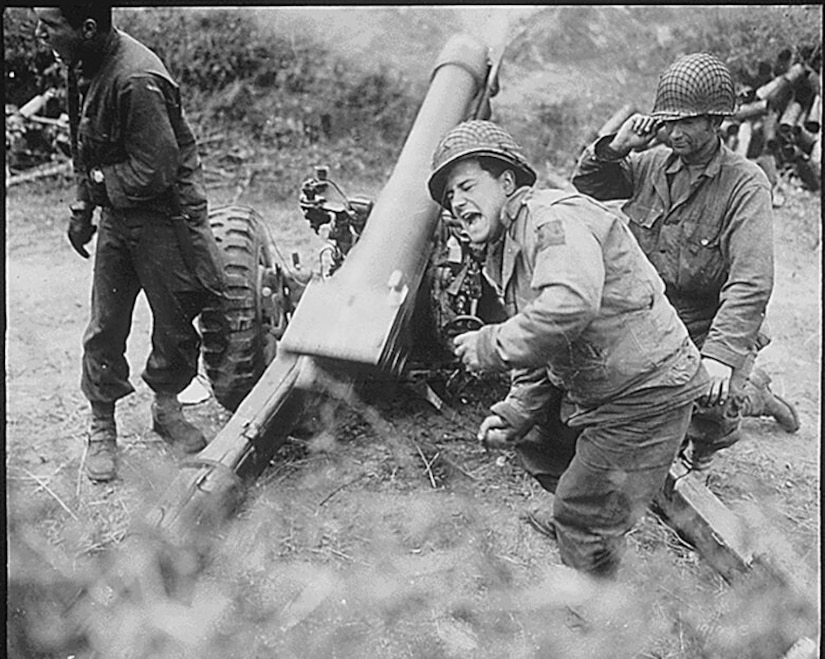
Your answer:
[4,7,418,195]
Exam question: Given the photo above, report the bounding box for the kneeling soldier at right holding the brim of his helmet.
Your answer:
[573,53,799,469]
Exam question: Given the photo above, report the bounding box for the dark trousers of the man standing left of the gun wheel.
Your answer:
[81,209,215,403]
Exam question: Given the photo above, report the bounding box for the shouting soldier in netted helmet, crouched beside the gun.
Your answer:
[429,121,708,576]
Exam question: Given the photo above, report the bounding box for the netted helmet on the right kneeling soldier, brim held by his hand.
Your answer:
[651,53,736,121]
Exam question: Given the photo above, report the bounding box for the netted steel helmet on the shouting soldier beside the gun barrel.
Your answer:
[427,119,536,205]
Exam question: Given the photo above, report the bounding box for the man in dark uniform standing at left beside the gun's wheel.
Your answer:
[35,2,223,481]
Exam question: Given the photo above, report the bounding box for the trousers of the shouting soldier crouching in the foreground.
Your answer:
[516,387,693,576]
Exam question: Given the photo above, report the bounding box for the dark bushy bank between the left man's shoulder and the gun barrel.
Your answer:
[118,8,418,148]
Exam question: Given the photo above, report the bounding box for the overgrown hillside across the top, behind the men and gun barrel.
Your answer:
[4,5,822,192]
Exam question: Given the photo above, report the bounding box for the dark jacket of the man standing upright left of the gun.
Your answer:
[77,30,223,291]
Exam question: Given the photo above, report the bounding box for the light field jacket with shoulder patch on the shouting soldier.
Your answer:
[478,188,704,428]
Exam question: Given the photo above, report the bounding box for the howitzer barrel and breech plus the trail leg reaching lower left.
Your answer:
[148,35,489,540]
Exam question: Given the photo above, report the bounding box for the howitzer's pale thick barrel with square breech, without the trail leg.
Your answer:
[282,35,488,373]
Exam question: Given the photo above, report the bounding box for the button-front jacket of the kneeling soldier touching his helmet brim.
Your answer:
[573,135,773,369]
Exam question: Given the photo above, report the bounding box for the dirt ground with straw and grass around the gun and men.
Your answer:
[5,147,822,658]
